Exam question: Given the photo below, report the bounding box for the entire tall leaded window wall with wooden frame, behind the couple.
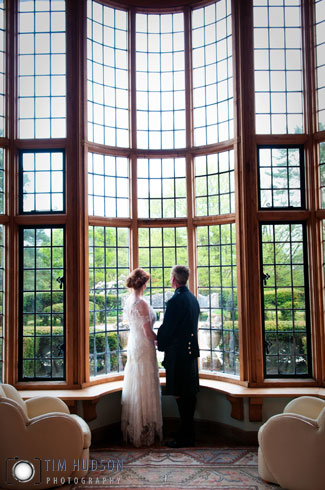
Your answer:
[0,0,325,387]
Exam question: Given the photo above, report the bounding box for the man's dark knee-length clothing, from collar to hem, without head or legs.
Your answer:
[157,286,200,396]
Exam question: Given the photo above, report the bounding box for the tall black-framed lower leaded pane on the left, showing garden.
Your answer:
[19,227,65,381]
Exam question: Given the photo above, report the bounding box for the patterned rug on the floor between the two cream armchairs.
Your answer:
[67,447,280,490]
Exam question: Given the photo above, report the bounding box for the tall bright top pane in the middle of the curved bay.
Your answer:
[136,13,186,149]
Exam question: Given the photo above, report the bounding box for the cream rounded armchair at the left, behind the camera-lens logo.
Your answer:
[0,384,91,490]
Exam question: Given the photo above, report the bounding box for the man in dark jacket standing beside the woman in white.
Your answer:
[157,265,200,448]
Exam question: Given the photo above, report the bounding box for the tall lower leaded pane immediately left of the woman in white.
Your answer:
[89,226,130,376]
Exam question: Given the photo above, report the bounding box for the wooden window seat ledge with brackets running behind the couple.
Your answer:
[20,377,325,422]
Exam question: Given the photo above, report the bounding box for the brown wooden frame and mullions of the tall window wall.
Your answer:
[0,0,325,389]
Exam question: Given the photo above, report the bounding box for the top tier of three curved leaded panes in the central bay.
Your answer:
[87,0,234,150]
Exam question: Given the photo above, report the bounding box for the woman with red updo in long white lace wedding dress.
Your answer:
[121,268,162,447]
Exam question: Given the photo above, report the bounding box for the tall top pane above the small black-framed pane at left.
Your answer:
[18,0,66,139]
